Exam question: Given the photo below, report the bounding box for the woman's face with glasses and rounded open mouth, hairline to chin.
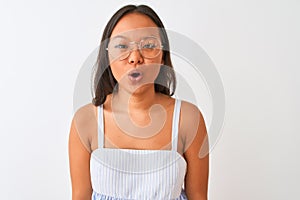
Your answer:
[108,13,163,92]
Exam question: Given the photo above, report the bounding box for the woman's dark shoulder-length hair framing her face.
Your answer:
[92,5,176,106]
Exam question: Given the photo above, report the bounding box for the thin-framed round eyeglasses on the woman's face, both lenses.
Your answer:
[106,36,163,60]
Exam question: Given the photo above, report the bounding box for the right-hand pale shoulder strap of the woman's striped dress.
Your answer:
[172,99,181,151]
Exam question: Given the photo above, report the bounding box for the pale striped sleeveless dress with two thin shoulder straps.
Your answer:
[90,99,187,200]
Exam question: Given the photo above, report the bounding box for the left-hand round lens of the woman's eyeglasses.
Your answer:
[108,37,130,60]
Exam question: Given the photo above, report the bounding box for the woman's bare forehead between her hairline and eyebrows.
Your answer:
[111,13,159,40]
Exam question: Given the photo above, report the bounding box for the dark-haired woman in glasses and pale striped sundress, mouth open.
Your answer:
[69,5,209,200]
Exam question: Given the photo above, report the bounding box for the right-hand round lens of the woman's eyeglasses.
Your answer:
[141,37,161,58]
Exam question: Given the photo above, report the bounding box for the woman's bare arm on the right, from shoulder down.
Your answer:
[182,102,209,200]
